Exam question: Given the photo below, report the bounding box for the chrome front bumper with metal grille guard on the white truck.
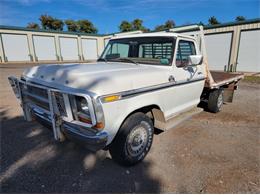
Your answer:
[9,77,108,151]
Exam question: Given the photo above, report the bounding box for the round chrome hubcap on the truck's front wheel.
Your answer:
[126,126,148,156]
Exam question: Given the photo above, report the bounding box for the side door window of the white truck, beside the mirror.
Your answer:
[175,40,196,67]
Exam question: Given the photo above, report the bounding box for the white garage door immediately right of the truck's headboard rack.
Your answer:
[205,33,232,71]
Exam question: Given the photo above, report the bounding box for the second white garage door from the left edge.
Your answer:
[33,36,56,61]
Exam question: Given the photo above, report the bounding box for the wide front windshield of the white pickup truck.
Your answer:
[99,37,175,65]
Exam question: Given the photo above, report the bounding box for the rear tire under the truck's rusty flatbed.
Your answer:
[208,89,224,113]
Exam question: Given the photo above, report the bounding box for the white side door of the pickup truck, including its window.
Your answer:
[165,38,205,117]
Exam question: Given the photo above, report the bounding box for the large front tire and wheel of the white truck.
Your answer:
[109,112,154,166]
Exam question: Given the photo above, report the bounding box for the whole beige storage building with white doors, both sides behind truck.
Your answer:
[0,19,260,72]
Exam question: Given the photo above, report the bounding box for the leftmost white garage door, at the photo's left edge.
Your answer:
[2,34,30,61]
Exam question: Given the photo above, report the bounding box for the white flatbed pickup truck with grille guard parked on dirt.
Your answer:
[9,26,243,165]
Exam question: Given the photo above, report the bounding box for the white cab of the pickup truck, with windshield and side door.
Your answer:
[99,32,206,118]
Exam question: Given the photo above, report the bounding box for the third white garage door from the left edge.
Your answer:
[60,37,79,60]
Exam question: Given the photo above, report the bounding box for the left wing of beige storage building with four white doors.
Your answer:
[0,27,104,63]
